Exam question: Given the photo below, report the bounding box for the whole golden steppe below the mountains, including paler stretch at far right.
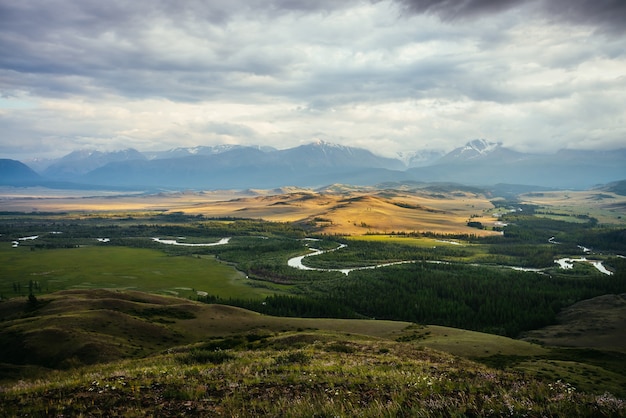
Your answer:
[0,185,626,235]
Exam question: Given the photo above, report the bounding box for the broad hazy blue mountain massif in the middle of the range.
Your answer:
[83,143,403,189]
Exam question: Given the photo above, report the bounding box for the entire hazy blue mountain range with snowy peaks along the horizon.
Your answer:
[0,139,626,189]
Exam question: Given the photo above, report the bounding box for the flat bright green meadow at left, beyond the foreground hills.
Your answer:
[0,243,280,299]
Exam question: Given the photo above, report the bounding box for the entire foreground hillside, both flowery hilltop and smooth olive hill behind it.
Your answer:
[0,290,626,417]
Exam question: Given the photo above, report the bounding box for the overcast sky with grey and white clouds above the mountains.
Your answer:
[0,0,626,160]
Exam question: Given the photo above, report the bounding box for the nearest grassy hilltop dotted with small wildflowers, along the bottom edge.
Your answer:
[0,326,626,417]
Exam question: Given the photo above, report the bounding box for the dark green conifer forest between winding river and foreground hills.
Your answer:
[199,258,626,337]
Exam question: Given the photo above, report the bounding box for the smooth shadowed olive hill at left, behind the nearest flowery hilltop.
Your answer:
[0,289,407,374]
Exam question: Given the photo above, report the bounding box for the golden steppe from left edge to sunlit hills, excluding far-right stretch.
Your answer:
[0,186,497,235]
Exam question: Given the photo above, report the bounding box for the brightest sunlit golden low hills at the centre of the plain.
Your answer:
[182,192,494,235]
